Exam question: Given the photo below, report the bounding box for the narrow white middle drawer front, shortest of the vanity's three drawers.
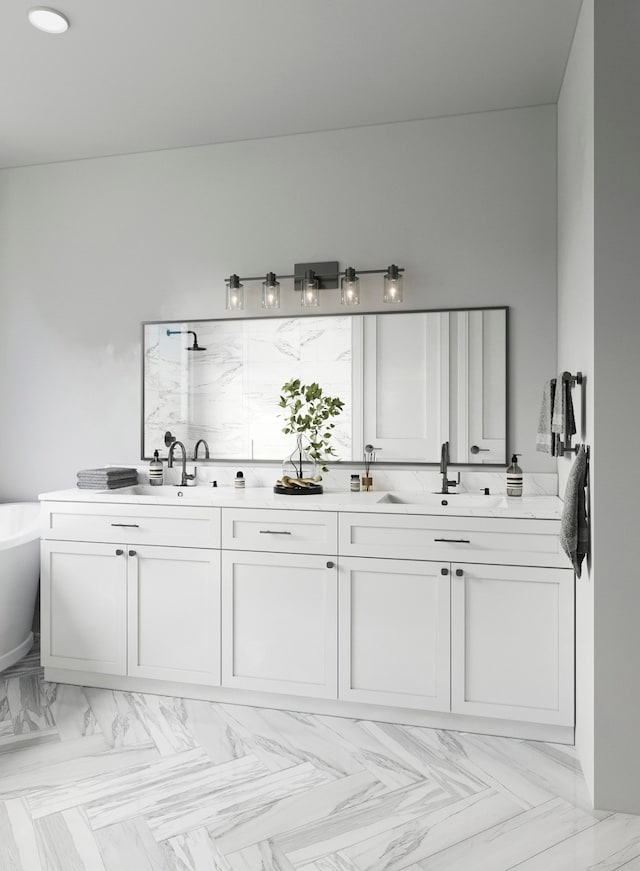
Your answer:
[222,508,338,555]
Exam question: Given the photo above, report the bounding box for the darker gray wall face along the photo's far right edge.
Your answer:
[593,0,640,813]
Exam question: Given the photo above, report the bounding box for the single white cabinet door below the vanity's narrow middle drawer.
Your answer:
[222,551,338,699]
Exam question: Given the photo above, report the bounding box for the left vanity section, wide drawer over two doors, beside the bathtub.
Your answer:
[41,502,220,686]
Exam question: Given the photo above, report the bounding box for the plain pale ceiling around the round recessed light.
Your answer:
[0,0,581,167]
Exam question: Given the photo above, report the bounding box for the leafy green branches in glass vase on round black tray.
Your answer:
[274,378,344,494]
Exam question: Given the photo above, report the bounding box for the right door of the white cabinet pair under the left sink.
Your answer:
[127,545,220,686]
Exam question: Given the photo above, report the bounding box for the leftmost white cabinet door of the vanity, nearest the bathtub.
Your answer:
[41,541,127,674]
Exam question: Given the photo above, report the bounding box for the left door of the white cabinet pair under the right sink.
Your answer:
[339,558,450,711]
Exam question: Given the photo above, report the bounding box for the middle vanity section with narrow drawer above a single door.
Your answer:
[222,508,338,699]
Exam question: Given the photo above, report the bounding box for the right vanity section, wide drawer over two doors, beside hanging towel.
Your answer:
[339,513,574,727]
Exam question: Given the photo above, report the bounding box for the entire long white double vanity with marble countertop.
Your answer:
[41,486,574,743]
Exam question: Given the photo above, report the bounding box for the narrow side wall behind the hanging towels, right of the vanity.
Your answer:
[558,0,596,795]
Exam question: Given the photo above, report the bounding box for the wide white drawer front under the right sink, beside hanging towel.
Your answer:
[339,513,567,567]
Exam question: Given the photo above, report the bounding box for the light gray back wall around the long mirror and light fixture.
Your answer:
[0,106,556,500]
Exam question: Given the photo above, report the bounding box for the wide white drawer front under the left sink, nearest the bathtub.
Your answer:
[41,502,220,548]
